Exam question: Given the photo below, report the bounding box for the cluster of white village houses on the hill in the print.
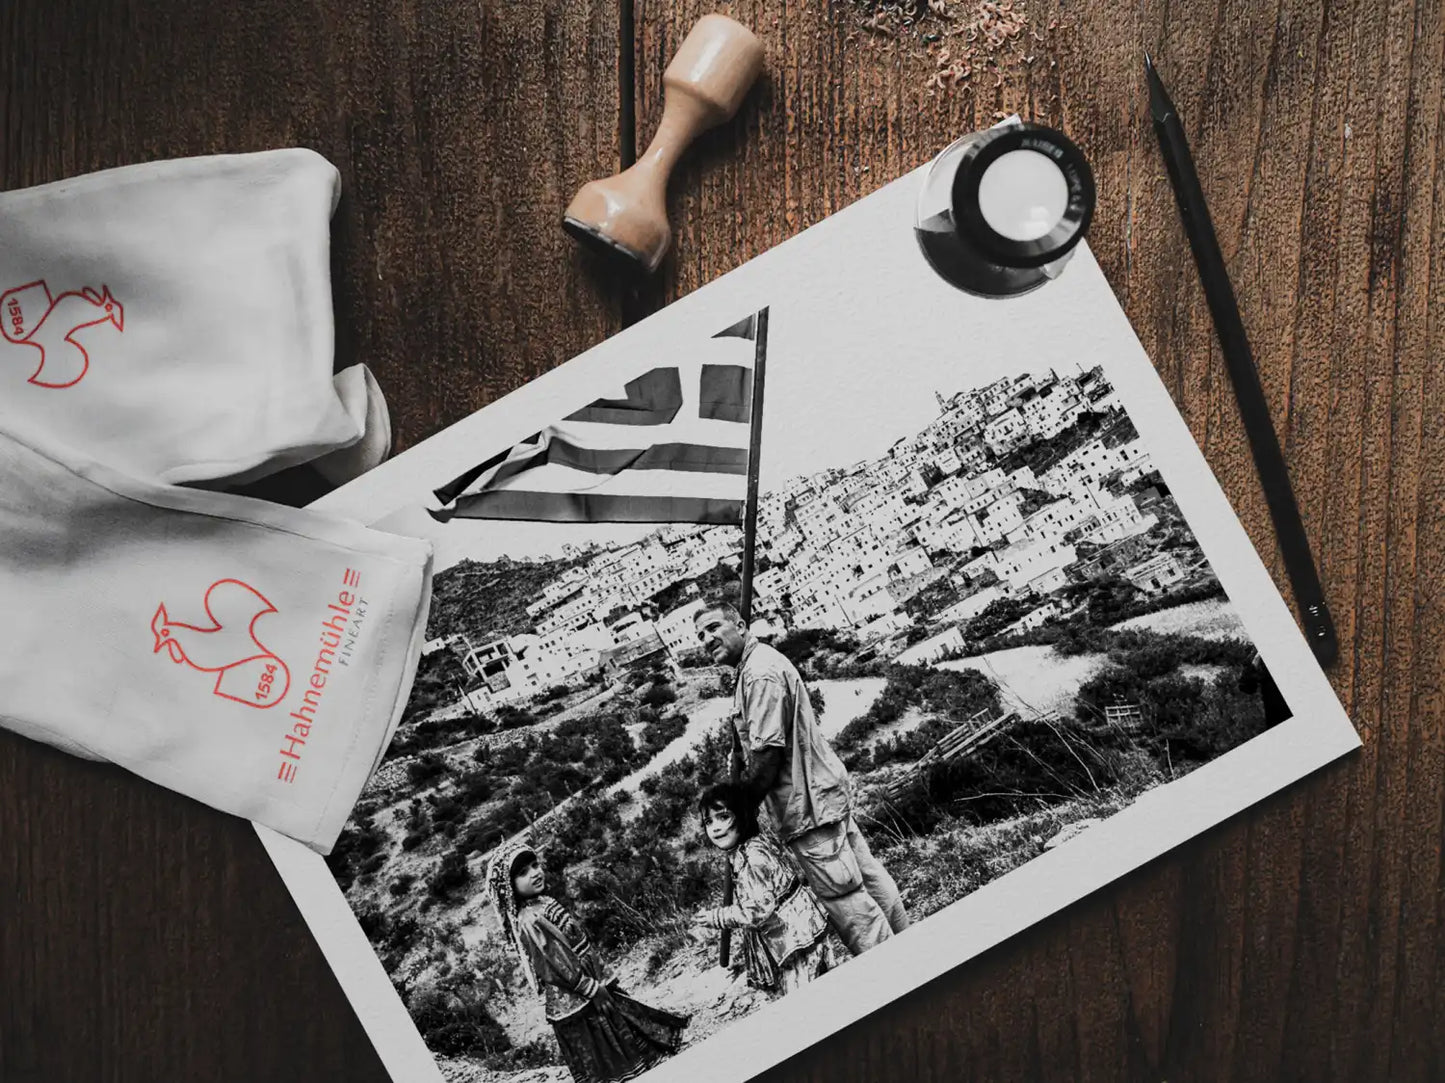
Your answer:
[425,367,1202,713]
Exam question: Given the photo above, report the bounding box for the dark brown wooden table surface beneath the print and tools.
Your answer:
[0,0,1445,1083]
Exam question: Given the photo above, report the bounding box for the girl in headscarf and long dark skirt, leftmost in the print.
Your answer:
[487,843,688,1083]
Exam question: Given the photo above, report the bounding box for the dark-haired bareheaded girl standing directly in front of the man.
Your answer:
[692,784,832,996]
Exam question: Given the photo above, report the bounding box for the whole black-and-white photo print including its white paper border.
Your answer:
[263,164,1357,1083]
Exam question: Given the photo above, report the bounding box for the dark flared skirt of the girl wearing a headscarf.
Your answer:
[551,985,689,1083]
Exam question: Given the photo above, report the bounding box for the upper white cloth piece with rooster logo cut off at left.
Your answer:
[0,149,390,484]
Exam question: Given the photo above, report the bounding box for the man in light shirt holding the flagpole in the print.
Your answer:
[695,602,909,956]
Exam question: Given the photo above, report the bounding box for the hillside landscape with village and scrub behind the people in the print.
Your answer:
[328,369,1272,1083]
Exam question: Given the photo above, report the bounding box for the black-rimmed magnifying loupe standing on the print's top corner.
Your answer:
[913,121,1094,296]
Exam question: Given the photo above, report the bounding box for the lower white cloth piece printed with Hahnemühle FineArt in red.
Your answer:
[0,419,432,853]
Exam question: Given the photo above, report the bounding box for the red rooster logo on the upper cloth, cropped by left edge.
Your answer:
[0,279,126,388]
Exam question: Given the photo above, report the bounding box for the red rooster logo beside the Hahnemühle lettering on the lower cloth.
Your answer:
[150,578,290,707]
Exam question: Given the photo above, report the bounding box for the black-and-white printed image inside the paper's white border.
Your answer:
[328,318,1287,1083]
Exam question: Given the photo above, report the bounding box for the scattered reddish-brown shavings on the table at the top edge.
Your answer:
[850,0,1068,93]
